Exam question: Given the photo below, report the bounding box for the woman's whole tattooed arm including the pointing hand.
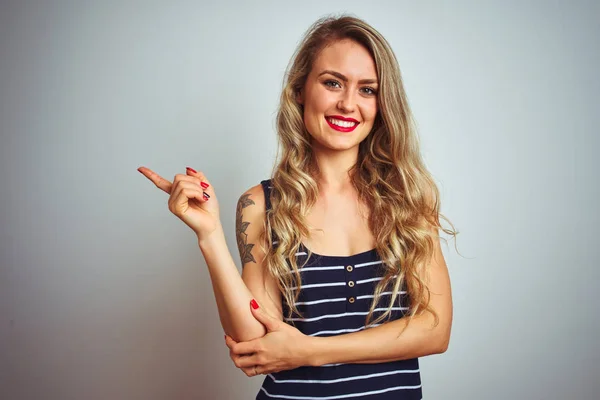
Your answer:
[138,167,283,341]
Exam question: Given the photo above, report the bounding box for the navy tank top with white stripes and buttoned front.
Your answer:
[256,180,422,400]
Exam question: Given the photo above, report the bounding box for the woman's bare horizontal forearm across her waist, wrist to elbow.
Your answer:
[308,313,450,366]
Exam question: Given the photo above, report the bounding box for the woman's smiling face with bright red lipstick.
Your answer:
[298,39,378,151]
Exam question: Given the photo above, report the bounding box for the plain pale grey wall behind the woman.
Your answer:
[0,0,600,400]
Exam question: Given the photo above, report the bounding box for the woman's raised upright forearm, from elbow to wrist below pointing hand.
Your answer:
[198,225,266,341]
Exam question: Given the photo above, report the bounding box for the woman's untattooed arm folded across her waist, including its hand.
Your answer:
[226,234,452,376]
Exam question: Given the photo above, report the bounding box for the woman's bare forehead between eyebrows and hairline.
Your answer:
[311,39,377,79]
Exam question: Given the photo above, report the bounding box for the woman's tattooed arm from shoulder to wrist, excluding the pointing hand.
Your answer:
[198,185,283,341]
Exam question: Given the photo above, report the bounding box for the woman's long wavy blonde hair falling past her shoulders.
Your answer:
[264,16,456,332]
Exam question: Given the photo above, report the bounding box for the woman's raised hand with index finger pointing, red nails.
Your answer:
[138,167,220,241]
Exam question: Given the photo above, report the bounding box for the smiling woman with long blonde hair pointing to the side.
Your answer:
[140,17,455,399]
